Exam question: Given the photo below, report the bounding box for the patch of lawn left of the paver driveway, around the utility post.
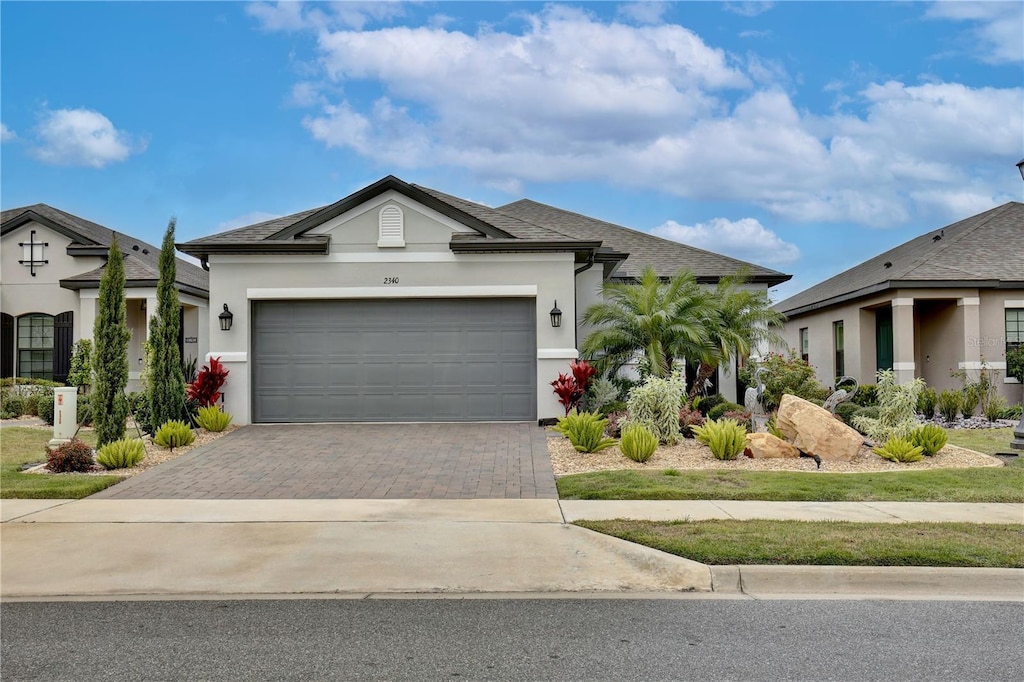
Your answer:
[0,426,122,499]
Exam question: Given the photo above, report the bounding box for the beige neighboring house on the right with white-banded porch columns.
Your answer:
[775,202,1024,402]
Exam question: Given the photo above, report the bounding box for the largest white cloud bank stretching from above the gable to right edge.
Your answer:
[282,5,1024,226]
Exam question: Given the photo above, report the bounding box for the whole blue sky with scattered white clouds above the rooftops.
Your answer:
[0,1,1024,300]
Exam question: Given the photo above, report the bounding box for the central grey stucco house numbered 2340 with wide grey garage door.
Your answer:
[178,176,788,424]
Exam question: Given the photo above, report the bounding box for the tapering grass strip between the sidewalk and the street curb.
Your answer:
[577,519,1024,568]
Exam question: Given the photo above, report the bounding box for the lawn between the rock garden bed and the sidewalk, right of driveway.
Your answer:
[558,429,1024,502]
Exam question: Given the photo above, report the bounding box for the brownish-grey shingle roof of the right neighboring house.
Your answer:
[774,202,1024,316]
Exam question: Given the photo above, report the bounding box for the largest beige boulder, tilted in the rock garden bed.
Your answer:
[775,394,864,462]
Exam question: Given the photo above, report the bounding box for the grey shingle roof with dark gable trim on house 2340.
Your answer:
[178,175,791,286]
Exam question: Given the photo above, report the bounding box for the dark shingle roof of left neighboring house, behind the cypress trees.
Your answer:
[0,199,210,292]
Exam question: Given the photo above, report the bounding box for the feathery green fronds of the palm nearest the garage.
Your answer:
[583,266,717,377]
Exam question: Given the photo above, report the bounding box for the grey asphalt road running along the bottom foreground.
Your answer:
[0,599,1024,681]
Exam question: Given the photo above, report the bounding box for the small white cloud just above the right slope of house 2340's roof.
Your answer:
[650,218,800,266]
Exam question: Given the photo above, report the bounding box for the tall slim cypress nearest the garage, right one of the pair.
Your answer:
[148,218,185,428]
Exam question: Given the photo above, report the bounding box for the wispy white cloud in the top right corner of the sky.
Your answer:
[925,2,1024,63]
